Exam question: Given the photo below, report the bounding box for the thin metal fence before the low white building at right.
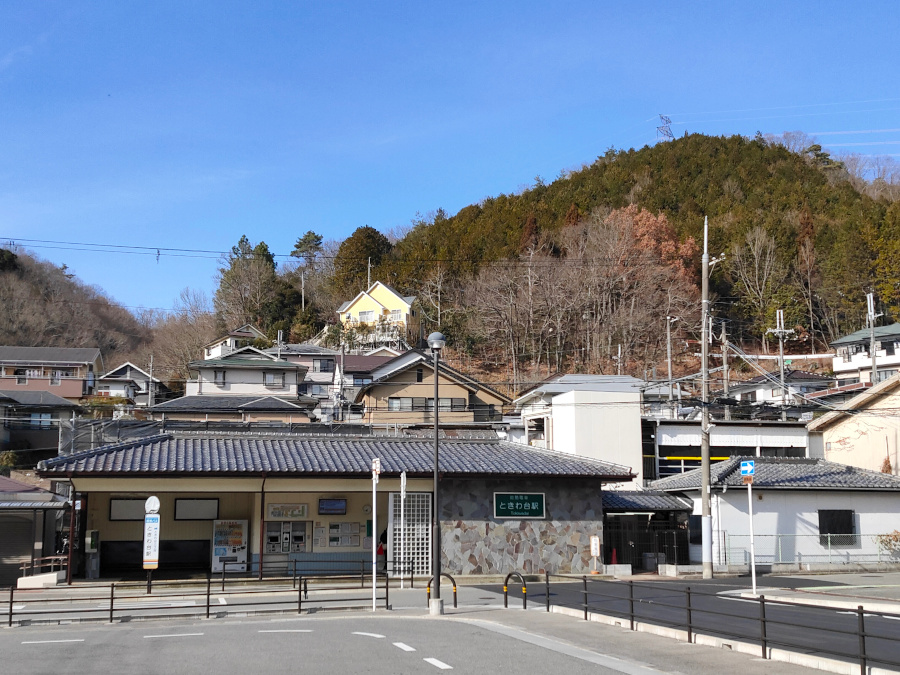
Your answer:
[725,533,900,566]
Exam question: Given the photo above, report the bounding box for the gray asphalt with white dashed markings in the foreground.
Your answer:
[0,613,661,675]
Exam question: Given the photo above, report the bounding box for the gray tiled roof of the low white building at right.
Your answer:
[653,457,900,492]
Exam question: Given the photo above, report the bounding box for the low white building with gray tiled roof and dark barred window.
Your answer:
[653,457,900,570]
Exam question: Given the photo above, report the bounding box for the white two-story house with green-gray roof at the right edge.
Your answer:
[830,323,900,385]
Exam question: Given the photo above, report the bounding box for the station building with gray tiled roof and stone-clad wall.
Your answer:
[38,432,632,577]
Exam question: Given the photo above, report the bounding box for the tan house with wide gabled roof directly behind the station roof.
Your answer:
[355,350,510,425]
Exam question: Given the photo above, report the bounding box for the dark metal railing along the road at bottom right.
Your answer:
[520,573,900,675]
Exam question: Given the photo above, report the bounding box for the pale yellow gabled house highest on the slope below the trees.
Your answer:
[338,281,420,345]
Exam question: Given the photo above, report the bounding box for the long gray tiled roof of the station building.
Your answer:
[39,434,633,481]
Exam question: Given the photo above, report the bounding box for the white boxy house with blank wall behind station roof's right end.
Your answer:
[513,374,643,486]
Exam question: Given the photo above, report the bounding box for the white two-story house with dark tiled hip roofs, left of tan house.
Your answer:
[152,347,318,423]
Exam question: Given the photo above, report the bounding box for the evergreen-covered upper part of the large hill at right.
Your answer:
[390,134,900,352]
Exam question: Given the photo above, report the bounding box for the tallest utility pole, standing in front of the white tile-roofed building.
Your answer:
[700,216,713,579]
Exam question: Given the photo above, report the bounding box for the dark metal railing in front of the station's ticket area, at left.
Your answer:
[0,573,391,626]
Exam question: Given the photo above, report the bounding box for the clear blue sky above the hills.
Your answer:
[0,0,900,308]
